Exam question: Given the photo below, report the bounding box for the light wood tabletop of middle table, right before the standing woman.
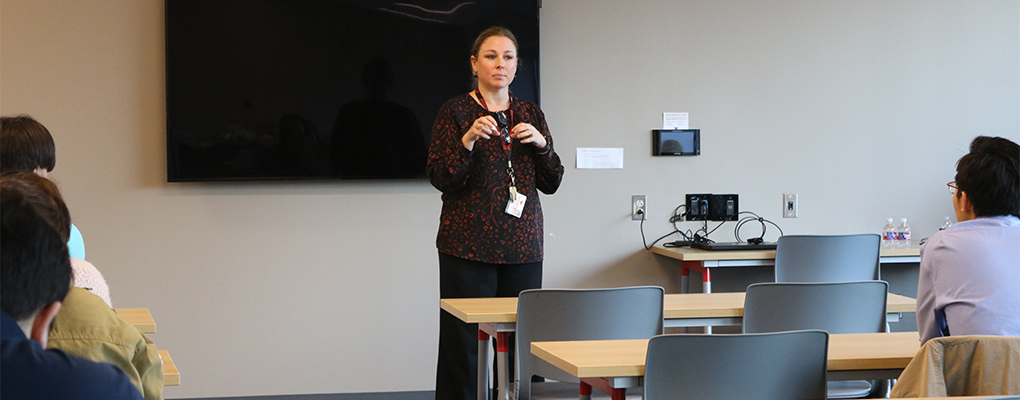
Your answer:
[440,292,917,323]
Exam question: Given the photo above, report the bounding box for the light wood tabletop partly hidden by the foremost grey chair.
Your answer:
[531,332,921,400]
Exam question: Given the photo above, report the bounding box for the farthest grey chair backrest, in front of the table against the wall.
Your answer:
[775,234,881,282]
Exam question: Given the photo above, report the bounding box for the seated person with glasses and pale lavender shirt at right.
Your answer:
[917,136,1020,344]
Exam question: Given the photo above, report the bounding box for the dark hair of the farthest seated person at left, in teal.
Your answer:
[0,114,57,172]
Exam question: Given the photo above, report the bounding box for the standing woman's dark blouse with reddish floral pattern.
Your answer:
[427,95,563,264]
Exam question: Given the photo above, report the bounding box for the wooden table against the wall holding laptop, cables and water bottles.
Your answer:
[652,245,921,293]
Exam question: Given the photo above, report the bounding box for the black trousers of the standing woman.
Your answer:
[436,253,542,400]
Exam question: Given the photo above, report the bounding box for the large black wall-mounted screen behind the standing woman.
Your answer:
[166,0,540,182]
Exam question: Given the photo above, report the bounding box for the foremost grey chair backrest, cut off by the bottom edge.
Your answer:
[644,331,828,400]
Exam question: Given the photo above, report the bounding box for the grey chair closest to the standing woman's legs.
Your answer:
[516,287,665,400]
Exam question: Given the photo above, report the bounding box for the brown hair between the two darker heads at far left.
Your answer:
[0,170,70,241]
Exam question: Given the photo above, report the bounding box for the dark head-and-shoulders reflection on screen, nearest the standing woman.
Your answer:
[329,57,428,178]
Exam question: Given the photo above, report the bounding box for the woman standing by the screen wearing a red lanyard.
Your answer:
[427,28,563,400]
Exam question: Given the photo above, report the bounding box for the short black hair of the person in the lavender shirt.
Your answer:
[956,136,1020,216]
